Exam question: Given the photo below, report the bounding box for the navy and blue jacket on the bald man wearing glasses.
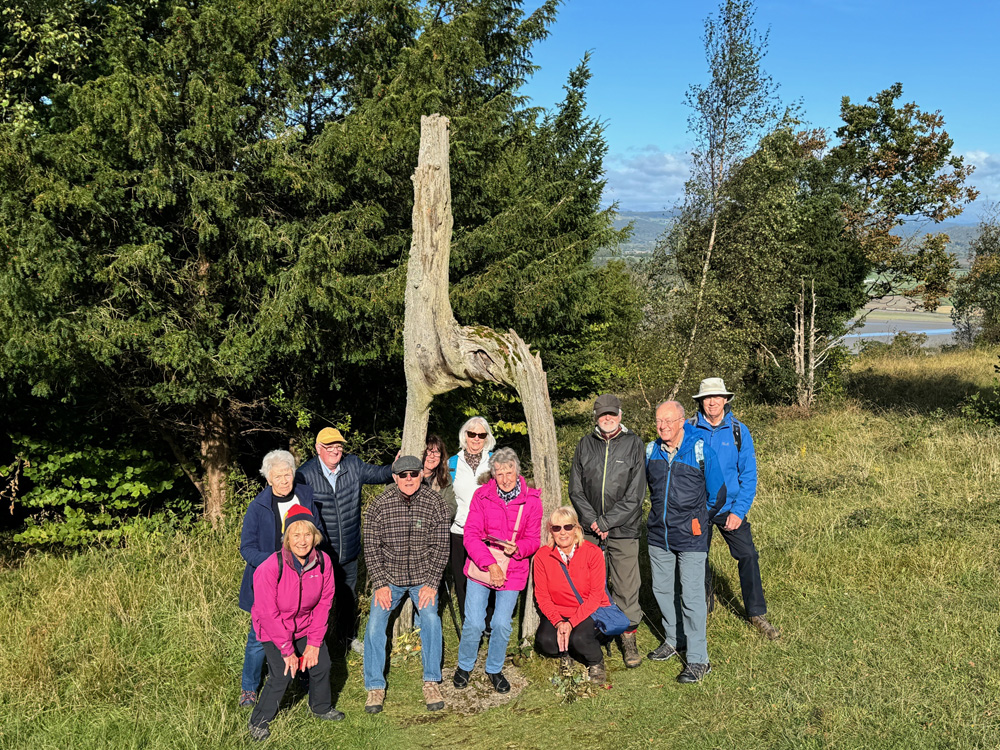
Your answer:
[646,424,726,552]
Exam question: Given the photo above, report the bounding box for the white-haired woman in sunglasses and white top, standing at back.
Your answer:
[448,417,497,622]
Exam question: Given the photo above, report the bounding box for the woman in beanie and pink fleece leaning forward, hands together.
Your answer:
[250,505,344,740]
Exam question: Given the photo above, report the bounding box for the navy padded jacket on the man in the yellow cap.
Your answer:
[295,454,392,563]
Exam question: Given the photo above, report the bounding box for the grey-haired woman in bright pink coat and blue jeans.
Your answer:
[453,448,542,693]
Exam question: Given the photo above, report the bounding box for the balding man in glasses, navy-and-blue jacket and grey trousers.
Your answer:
[646,401,726,683]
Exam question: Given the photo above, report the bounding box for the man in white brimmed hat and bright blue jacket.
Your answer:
[693,378,781,641]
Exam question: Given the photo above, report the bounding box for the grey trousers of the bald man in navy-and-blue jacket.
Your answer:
[649,544,708,664]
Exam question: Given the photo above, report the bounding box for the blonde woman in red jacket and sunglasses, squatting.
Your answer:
[532,506,610,683]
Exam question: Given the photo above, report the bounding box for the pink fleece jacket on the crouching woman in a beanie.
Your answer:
[250,549,334,656]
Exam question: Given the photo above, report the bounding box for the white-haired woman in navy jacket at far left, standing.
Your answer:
[239,450,326,708]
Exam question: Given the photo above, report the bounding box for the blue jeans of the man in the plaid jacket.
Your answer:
[365,584,442,690]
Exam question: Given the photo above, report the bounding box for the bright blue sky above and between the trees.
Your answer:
[523,0,1000,221]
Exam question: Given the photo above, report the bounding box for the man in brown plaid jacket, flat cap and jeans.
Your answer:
[363,456,451,714]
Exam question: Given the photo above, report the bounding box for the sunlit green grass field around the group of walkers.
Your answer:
[0,352,1000,750]
